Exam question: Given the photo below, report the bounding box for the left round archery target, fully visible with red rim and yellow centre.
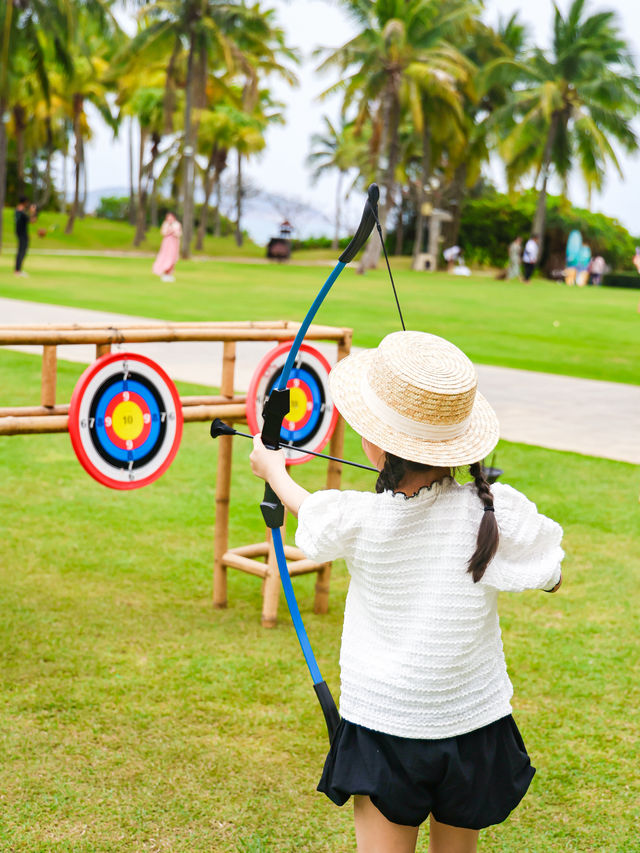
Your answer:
[69,353,182,489]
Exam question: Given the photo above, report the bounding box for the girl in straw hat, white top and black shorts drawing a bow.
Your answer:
[251,332,563,853]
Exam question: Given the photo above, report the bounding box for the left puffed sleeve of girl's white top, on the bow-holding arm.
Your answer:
[296,489,361,563]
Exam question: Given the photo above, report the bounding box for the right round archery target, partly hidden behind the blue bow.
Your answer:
[247,342,338,465]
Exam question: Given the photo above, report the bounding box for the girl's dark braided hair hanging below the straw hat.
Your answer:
[376,453,499,583]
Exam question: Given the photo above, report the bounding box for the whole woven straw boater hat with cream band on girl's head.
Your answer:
[329,332,499,466]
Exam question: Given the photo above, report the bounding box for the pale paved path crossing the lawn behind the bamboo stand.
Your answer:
[0,299,640,464]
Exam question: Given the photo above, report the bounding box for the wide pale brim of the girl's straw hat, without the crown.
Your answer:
[329,350,500,466]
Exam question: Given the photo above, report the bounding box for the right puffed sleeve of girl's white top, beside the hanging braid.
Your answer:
[480,483,564,592]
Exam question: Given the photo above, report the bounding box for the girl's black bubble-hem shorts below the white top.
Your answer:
[318,715,535,829]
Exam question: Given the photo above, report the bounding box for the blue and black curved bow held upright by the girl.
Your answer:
[260,184,380,742]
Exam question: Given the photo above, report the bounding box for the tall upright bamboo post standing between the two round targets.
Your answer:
[213,341,236,609]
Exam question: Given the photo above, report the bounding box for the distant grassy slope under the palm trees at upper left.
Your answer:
[2,208,265,258]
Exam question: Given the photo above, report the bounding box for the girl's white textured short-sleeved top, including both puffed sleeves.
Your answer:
[296,478,564,738]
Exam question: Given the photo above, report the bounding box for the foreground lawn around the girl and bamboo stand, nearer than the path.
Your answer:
[0,352,640,853]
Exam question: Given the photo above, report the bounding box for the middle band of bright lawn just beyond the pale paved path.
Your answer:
[0,254,640,384]
